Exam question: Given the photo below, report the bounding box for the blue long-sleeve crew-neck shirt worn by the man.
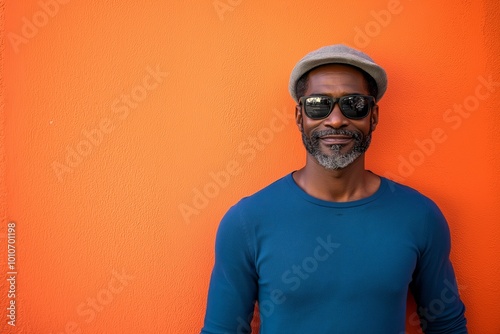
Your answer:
[201,174,467,334]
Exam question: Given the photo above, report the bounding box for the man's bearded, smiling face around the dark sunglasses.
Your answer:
[296,64,378,170]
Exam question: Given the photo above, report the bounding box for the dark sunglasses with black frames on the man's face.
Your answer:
[299,94,375,119]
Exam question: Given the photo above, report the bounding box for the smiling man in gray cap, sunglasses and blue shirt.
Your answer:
[202,45,467,334]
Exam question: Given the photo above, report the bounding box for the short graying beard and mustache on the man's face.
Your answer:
[302,129,372,170]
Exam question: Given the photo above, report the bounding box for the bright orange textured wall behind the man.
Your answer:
[0,0,500,334]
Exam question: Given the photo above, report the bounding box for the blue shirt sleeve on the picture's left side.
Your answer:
[201,207,258,334]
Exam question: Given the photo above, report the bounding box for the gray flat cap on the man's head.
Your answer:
[288,44,387,103]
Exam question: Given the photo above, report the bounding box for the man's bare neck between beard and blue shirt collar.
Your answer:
[293,154,380,202]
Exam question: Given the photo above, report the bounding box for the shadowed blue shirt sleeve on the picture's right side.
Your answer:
[410,203,467,334]
